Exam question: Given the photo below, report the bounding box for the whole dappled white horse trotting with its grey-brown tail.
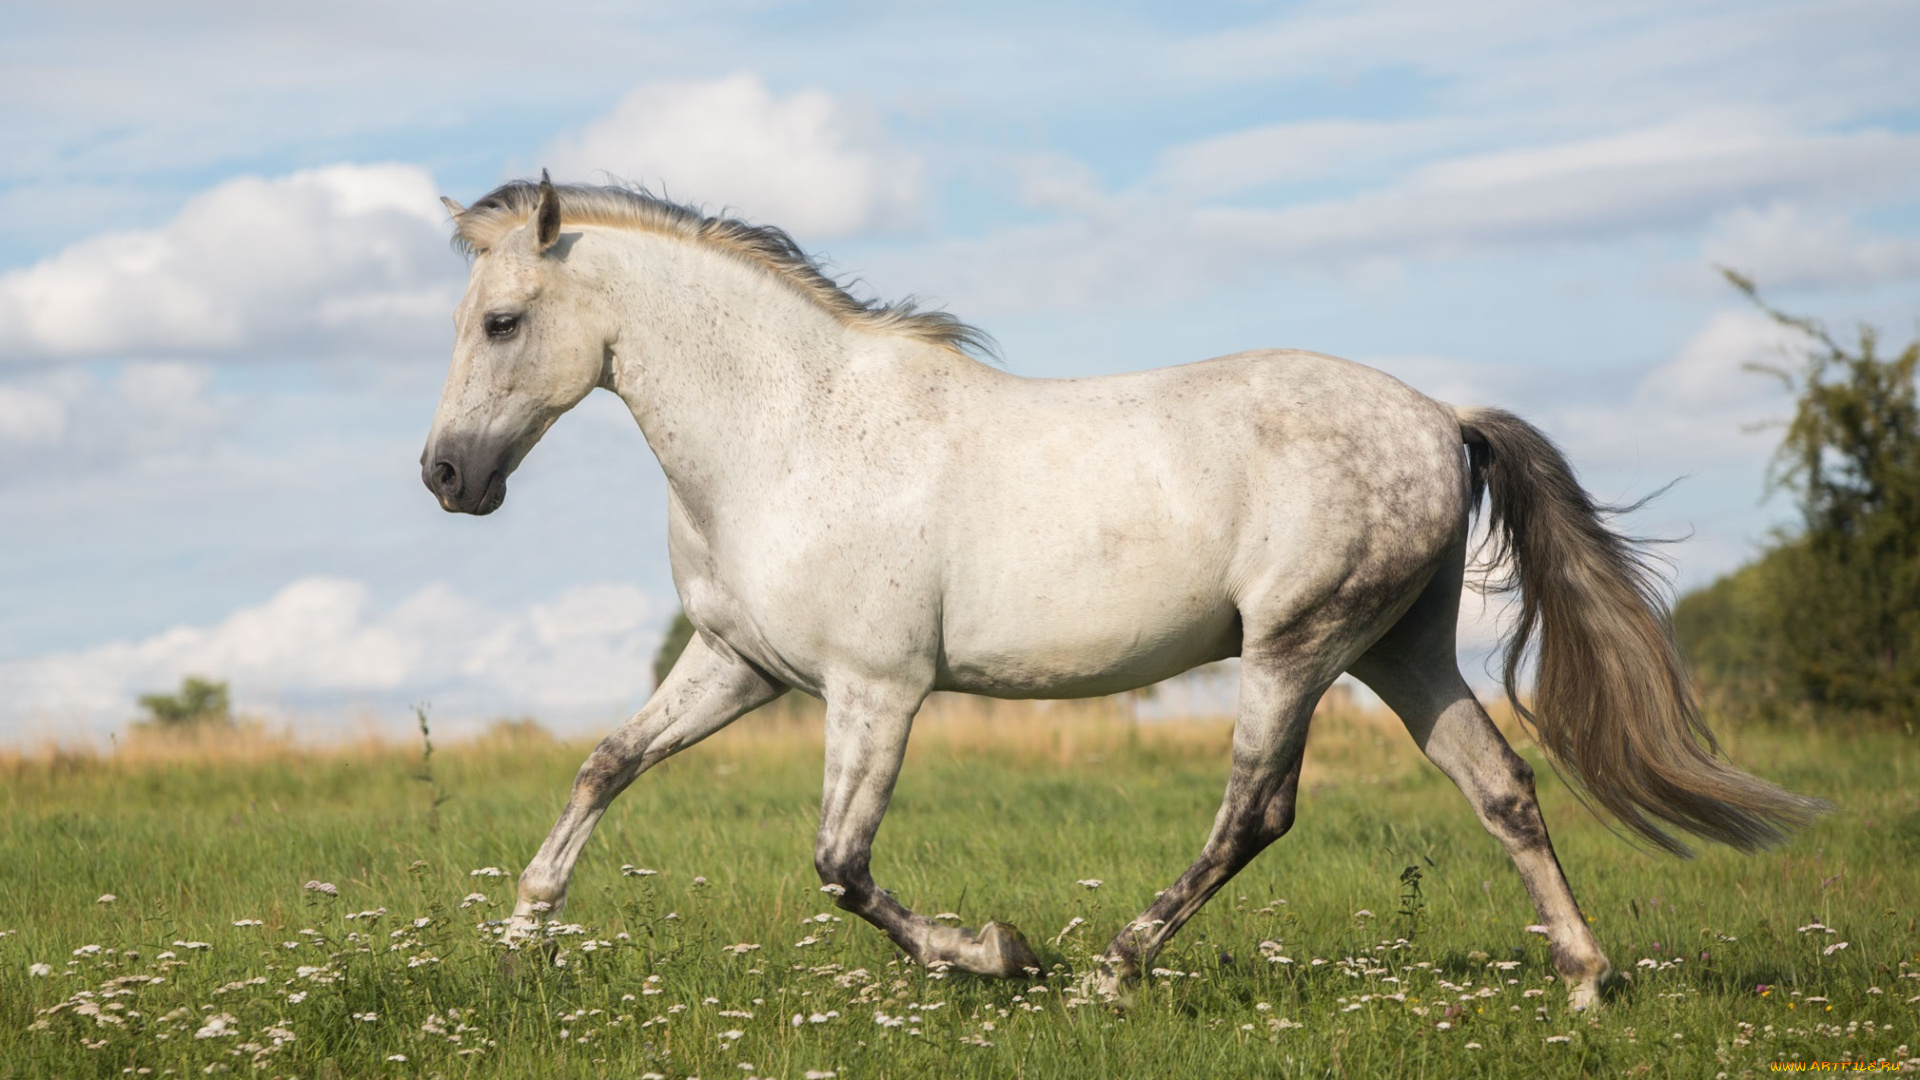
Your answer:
[420,177,1818,1007]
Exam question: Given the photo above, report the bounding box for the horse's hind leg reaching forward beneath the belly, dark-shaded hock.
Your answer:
[1098,634,1338,994]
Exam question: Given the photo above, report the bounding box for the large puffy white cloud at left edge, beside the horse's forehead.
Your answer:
[0,165,463,359]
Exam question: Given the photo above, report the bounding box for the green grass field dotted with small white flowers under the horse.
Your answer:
[0,700,1920,1080]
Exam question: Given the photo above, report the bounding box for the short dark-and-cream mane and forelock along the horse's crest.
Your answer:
[453,181,993,356]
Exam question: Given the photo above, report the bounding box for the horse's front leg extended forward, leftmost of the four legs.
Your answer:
[509,634,785,938]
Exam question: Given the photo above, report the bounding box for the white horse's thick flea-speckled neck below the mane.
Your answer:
[599,234,847,503]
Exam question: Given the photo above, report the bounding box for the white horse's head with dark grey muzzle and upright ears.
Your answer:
[420,173,611,513]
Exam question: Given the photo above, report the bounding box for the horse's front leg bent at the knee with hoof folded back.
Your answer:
[814,684,1041,978]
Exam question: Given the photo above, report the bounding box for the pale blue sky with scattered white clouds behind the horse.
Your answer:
[0,0,1920,742]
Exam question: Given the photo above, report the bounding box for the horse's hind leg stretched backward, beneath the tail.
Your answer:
[1352,561,1609,1009]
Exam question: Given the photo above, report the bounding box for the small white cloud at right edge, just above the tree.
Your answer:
[1707,202,1920,288]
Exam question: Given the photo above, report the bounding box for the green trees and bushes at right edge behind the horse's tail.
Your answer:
[1674,271,1920,721]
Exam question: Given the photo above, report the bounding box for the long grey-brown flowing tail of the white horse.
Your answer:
[1457,401,1828,855]
